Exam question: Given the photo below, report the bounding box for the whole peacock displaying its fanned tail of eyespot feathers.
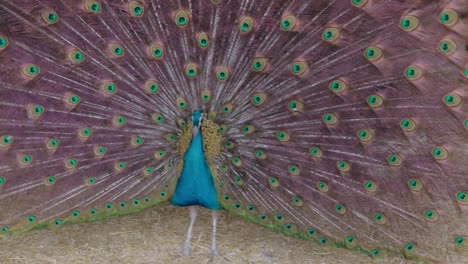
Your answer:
[0,0,468,262]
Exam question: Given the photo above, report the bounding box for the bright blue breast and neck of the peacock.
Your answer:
[171,130,221,210]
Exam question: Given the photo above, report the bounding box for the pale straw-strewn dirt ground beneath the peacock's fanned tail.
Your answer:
[0,206,416,264]
